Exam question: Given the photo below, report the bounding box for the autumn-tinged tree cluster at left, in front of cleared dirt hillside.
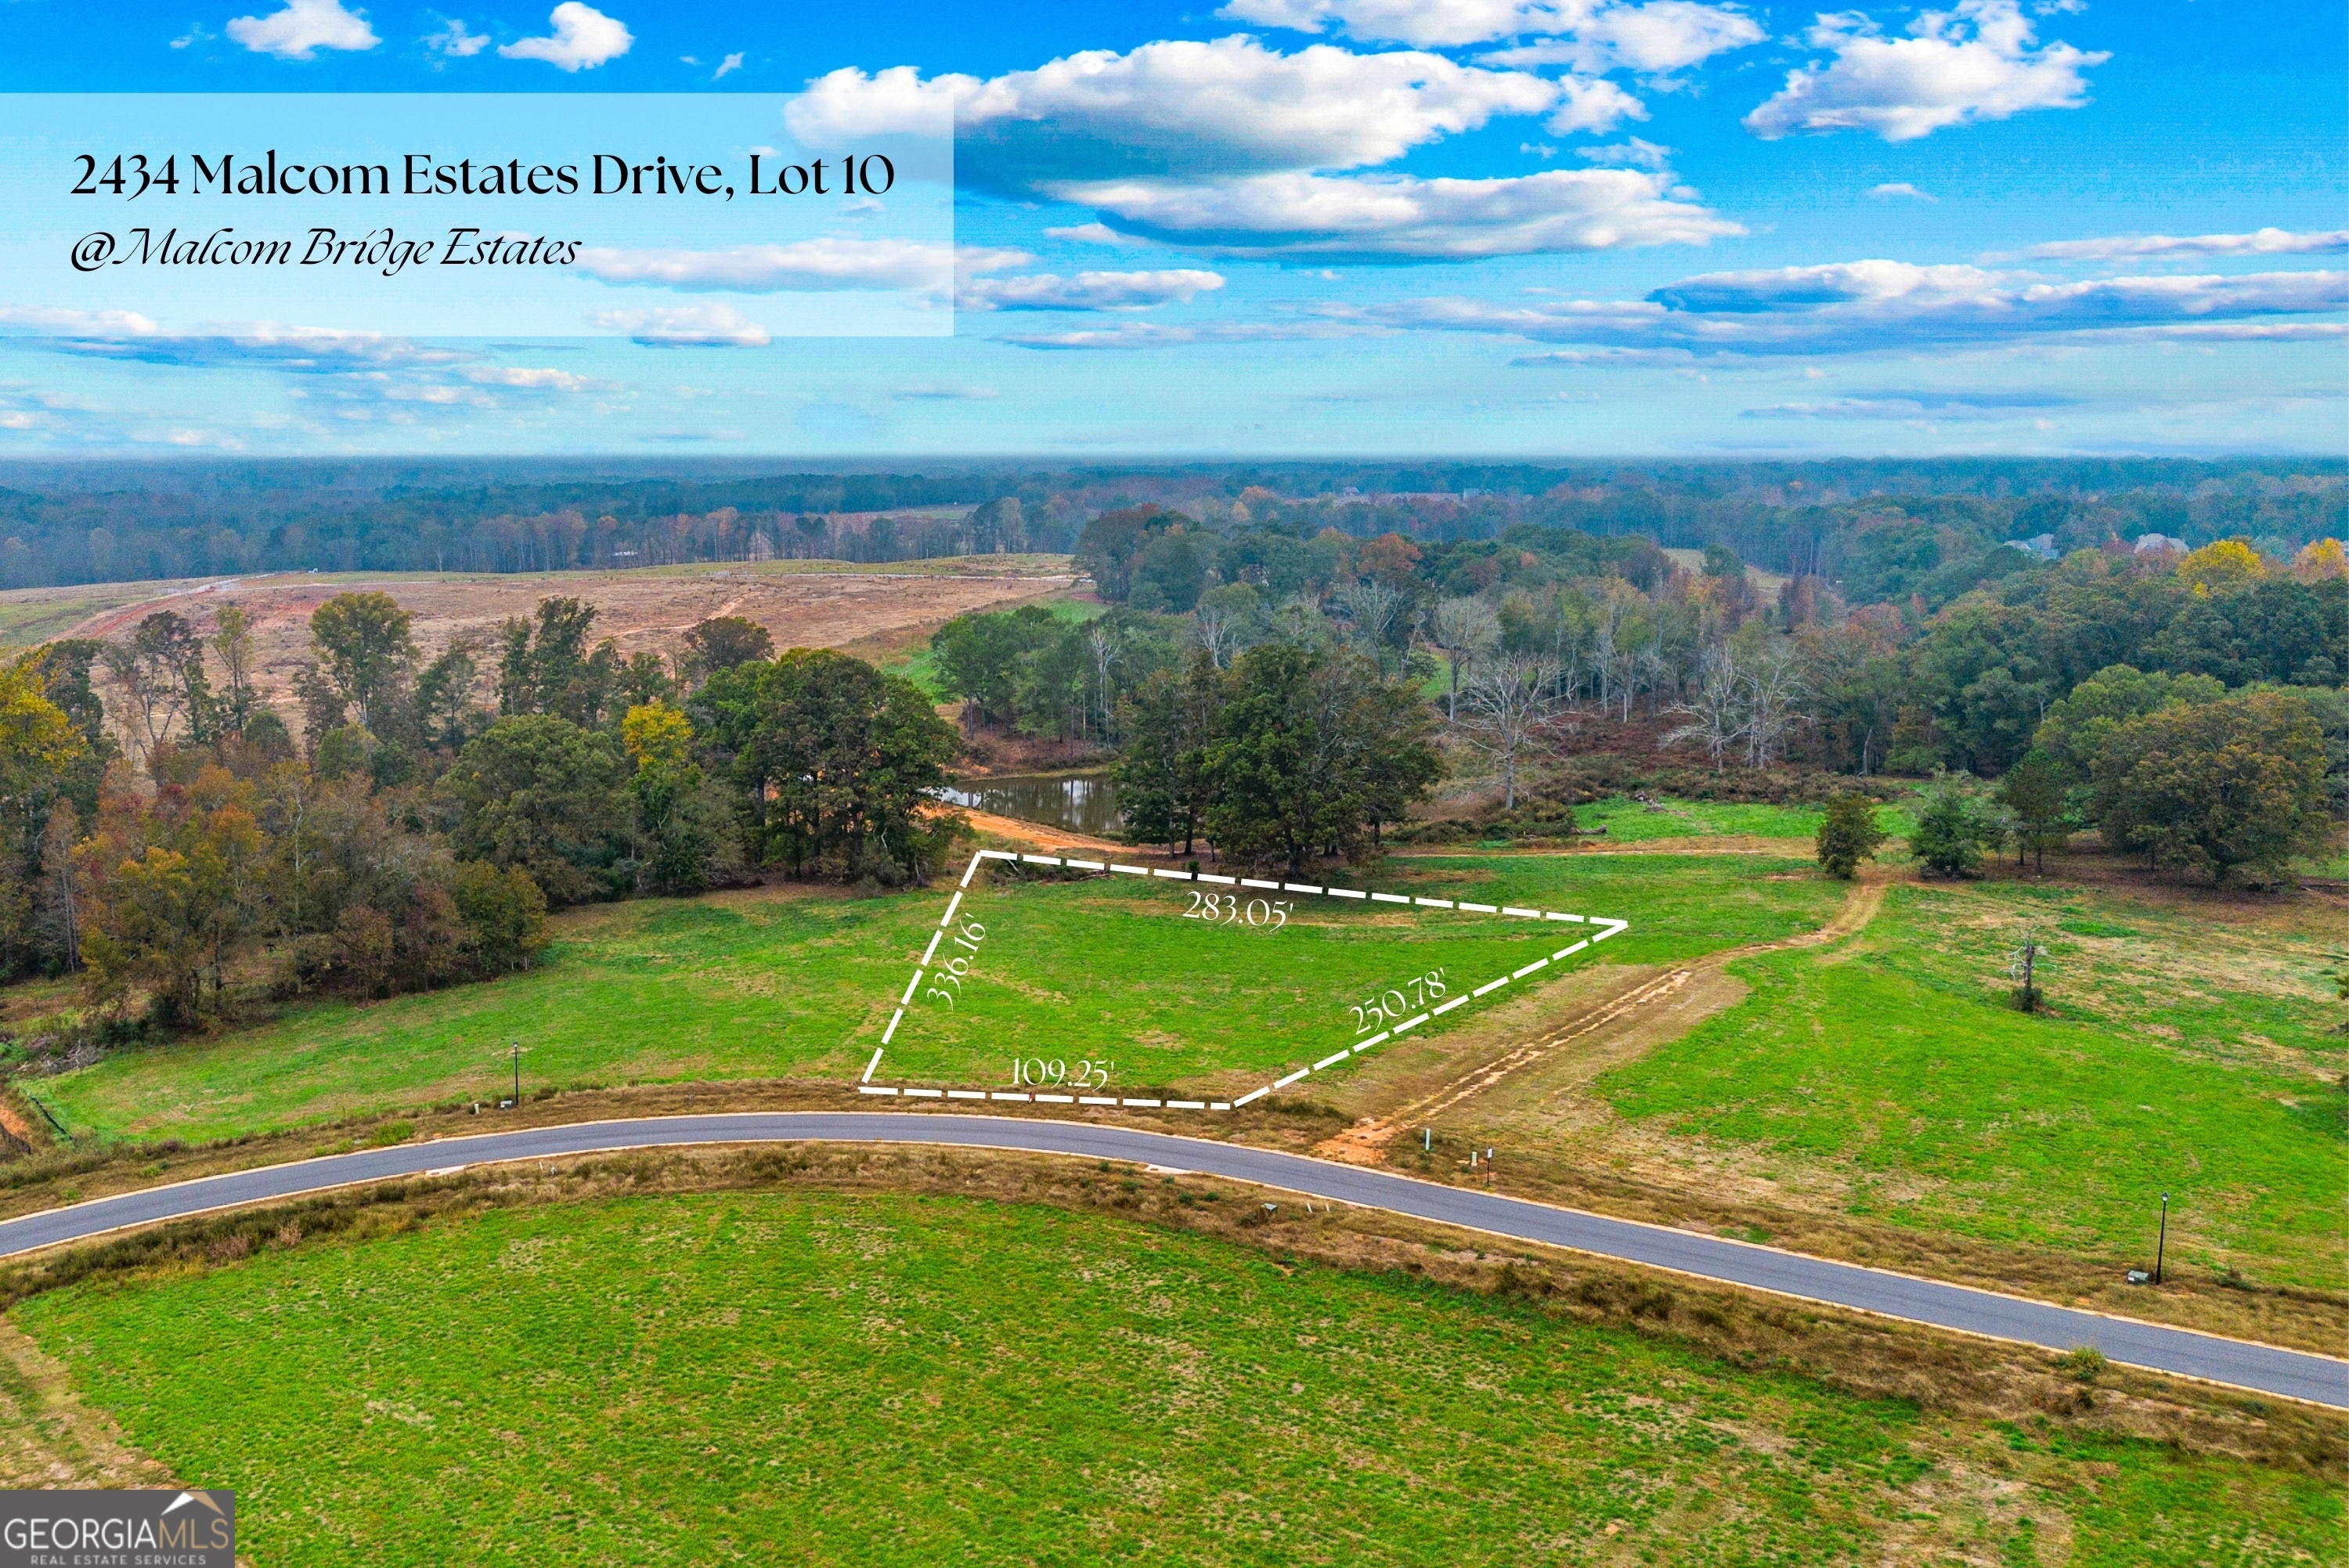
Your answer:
[0,594,961,1026]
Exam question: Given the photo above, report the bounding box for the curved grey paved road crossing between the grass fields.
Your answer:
[0,1110,2349,1408]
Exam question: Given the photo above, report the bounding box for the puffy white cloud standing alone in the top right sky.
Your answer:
[1745,0,2112,141]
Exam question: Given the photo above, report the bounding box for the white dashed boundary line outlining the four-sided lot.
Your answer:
[857,849,1630,1110]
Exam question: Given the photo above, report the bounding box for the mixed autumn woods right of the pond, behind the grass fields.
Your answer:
[935,516,2349,880]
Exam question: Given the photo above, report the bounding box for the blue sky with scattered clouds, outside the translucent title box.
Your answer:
[0,0,2349,460]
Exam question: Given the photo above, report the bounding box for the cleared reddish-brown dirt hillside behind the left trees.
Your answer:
[0,557,1076,712]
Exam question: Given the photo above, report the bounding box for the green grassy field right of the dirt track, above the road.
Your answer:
[1597,882,2349,1289]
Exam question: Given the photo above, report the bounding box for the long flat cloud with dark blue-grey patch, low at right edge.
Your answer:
[1325,261,2349,357]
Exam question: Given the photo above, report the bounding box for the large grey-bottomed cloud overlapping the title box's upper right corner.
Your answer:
[785,38,1560,193]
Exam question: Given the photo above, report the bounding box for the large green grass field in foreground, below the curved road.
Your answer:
[12,1192,2344,1568]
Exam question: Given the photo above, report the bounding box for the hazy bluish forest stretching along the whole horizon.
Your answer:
[0,458,2349,604]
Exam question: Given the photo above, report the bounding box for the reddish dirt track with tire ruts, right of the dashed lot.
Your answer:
[1313,875,1886,1164]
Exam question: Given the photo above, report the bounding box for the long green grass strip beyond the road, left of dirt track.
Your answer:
[40,856,1844,1138]
